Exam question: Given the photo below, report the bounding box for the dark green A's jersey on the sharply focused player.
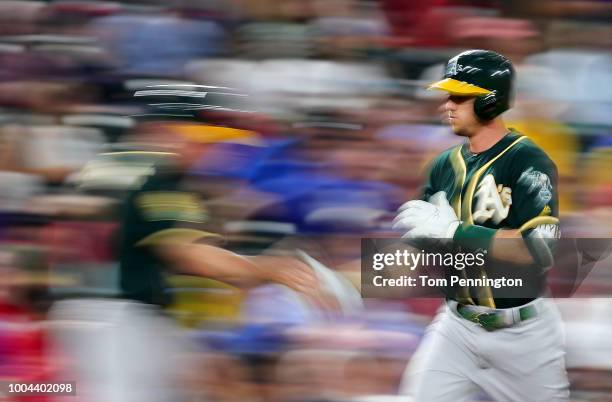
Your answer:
[422,131,559,308]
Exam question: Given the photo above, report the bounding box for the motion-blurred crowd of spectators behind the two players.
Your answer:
[0,0,612,402]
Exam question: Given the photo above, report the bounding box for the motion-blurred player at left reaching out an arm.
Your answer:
[47,124,318,402]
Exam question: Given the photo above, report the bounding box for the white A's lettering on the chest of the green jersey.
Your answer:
[472,174,512,224]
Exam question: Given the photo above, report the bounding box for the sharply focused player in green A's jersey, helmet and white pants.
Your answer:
[395,50,569,402]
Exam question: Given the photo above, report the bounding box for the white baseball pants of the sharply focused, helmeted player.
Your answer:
[400,299,569,402]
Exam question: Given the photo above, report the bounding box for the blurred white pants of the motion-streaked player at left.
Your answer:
[49,299,189,402]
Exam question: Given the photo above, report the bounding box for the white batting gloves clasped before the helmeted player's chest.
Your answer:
[393,191,461,239]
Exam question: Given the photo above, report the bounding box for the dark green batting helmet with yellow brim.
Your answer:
[429,50,514,120]
